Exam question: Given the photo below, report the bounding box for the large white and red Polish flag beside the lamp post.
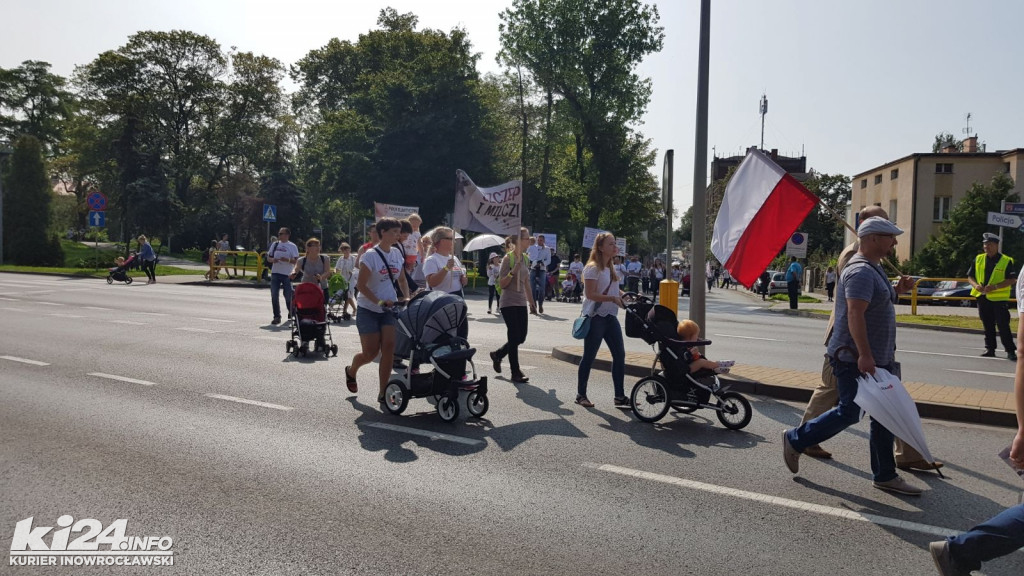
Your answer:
[711,150,818,288]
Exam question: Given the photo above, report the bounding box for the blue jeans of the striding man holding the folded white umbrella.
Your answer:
[786,360,896,482]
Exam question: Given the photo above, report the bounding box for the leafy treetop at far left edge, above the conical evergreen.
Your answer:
[0,60,74,153]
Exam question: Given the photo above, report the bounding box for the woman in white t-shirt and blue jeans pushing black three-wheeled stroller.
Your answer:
[575,232,630,408]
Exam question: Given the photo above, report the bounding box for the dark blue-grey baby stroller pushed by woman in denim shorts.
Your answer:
[384,291,489,422]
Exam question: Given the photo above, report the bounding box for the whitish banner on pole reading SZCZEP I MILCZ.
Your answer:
[452,170,522,236]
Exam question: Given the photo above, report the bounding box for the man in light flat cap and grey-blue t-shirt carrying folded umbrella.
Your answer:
[781,216,922,496]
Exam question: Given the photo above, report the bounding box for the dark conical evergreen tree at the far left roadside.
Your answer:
[3,135,63,265]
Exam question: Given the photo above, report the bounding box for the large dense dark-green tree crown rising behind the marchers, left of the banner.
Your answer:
[292,8,496,228]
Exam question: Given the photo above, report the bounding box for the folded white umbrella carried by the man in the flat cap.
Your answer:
[854,368,941,474]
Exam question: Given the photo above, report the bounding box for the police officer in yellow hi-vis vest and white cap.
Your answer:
[967,232,1017,362]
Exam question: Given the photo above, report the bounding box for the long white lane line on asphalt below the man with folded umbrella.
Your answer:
[584,463,961,536]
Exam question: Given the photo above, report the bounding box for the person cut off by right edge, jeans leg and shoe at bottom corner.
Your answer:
[928,274,1024,576]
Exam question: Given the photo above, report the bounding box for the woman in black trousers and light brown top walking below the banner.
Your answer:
[490,228,537,384]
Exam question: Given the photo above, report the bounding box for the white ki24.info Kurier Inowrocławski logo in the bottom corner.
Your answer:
[8,515,174,566]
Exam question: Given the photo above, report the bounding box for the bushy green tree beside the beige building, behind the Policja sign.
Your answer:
[912,173,1024,278]
